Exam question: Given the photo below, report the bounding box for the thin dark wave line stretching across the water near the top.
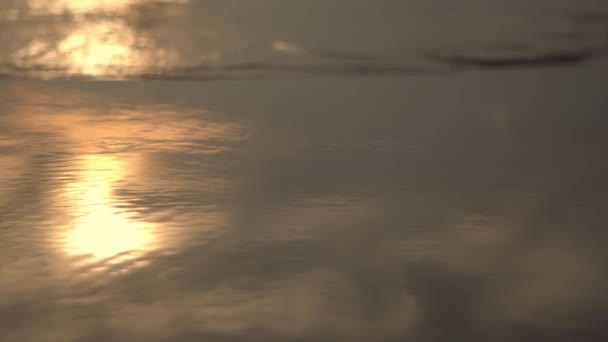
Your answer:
[0,47,608,80]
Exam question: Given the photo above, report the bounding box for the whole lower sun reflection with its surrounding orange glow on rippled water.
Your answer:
[0,82,252,273]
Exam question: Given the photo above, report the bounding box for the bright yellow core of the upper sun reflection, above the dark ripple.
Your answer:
[15,0,177,76]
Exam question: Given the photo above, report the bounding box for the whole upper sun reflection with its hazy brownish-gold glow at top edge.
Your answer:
[7,0,242,79]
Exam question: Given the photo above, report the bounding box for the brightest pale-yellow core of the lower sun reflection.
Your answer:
[64,155,155,259]
